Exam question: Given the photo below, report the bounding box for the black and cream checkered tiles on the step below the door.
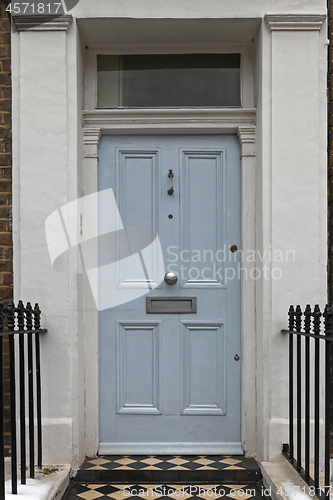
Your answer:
[63,455,270,500]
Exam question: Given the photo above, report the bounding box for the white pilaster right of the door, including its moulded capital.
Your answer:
[257,14,327,460]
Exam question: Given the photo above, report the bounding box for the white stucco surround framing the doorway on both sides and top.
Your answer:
[12,0,327,465]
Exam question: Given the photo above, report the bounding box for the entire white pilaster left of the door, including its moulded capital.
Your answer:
[12,16,77,463]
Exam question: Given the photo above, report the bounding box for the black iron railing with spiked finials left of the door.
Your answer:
[0,299,47,500]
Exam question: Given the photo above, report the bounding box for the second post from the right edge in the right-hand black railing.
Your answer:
[313,304,321,491]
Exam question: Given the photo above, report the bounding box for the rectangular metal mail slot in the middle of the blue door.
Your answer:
[146,297,197,314]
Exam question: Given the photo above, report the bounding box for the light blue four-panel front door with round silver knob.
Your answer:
[99,135,242,454]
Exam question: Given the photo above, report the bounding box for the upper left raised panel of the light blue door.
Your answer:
[116,148,161,288]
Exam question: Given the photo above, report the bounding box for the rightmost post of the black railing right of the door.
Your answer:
[324,305,332,498]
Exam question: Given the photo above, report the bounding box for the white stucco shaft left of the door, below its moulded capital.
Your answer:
[12,15,84,463]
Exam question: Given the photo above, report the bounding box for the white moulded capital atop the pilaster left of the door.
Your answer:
[12,14,73,31]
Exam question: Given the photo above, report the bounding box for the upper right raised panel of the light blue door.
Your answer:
[180,150,225,288]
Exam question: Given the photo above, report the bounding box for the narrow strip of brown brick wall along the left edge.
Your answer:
[0,0,13,455]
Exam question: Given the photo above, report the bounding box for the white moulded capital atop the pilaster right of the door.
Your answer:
[264,14,326,31]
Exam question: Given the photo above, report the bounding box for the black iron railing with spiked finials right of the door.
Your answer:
[282,305,333,498]
